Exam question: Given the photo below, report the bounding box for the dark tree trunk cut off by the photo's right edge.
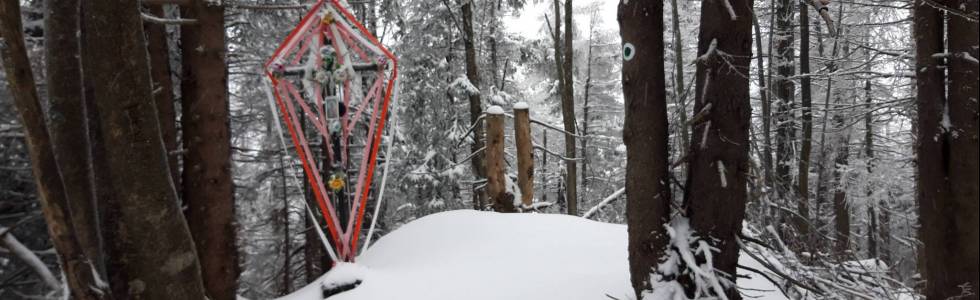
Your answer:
[940,0,980,297]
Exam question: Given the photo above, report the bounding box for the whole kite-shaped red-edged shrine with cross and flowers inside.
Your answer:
[265,0,398,261]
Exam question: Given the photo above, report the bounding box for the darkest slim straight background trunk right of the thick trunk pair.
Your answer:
[795,5,813,249]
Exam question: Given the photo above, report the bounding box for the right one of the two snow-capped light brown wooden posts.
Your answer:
[514,102,534,210]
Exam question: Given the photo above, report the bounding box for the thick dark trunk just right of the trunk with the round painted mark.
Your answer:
[682,0,752,299]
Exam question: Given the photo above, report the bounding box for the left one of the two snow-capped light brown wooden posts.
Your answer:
[486,106,515,212]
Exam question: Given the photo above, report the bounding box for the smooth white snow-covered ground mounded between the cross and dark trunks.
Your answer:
[284,210,786,300]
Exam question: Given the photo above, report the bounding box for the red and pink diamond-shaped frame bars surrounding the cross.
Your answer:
[265,0,398,262]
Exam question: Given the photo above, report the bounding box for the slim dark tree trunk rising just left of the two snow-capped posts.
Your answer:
[461,0,487,209]
